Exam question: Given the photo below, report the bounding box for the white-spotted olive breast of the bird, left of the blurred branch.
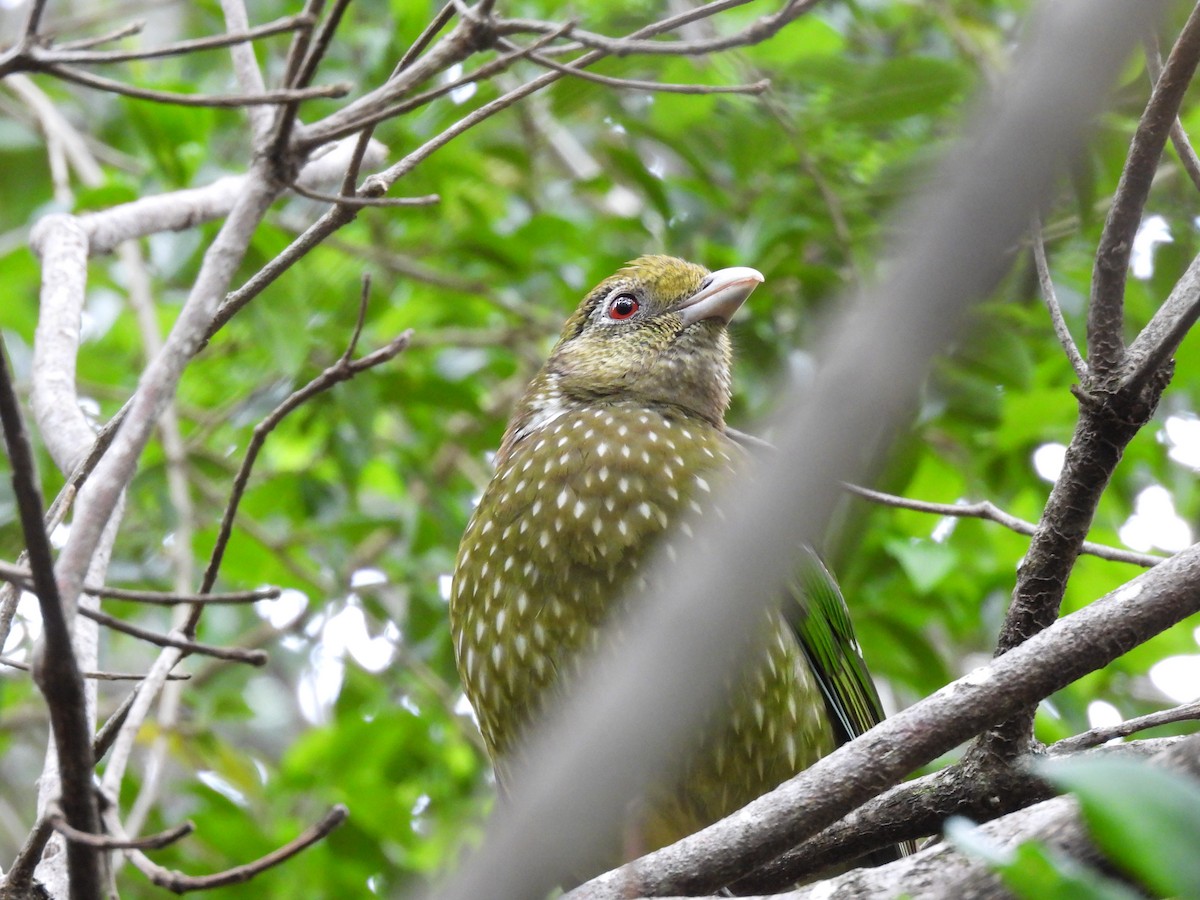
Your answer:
[450,404,731,756]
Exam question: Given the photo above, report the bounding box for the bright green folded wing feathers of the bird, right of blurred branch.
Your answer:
[786,551,883,744]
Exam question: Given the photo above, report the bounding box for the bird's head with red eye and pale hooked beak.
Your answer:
[527,256,763,426]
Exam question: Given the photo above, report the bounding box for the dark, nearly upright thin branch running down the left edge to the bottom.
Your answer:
[0,336,100,900]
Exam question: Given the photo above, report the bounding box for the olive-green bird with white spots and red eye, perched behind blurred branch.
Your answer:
[450,256,883,852]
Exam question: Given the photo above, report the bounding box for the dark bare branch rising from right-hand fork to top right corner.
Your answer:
[1087,0,1200,378]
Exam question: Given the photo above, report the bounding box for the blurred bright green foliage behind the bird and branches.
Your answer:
[0,0,1200,898]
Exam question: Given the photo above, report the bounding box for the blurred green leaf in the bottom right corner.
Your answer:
[1037,758,1200,896]
